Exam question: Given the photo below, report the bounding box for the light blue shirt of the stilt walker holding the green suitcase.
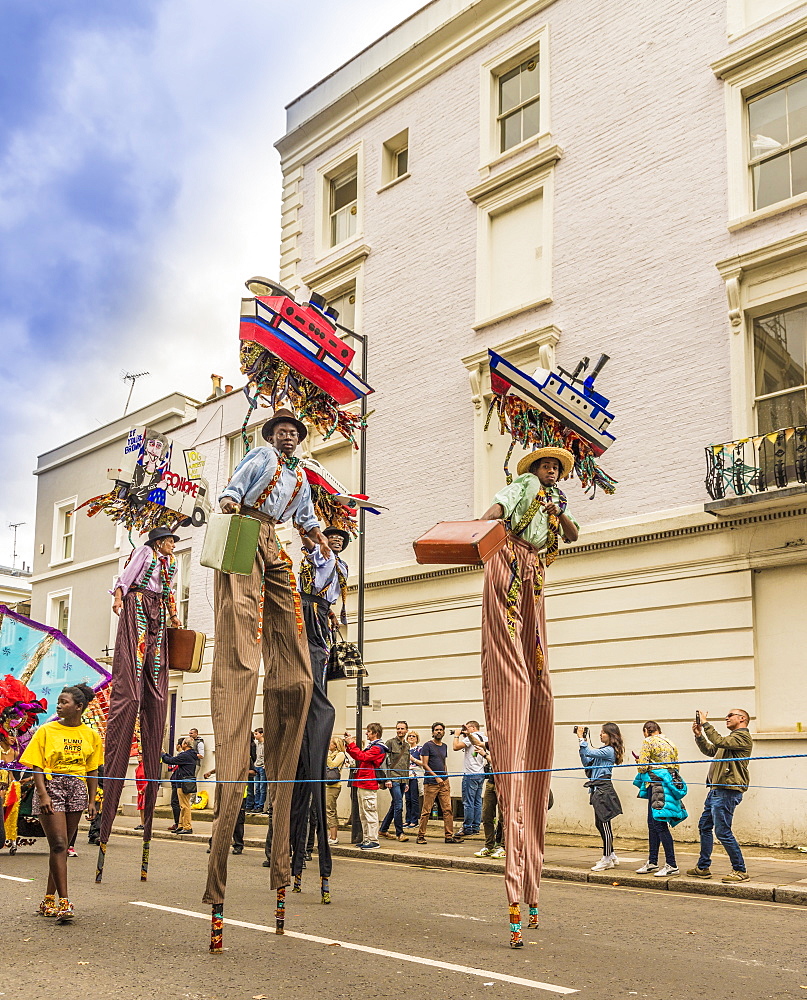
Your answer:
[224,445,319,534]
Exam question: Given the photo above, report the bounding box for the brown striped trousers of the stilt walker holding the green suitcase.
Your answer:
[202,510,313,903]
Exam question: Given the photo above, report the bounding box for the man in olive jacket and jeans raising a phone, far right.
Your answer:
[687,708,754,882]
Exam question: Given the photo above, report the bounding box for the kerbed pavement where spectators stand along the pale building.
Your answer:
[113,808,807,906]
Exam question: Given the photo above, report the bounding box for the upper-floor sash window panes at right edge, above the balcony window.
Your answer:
[748,77,807,209]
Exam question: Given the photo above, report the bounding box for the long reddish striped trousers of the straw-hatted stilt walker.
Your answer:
[482,535,554,906]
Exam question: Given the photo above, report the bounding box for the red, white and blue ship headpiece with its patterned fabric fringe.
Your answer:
[239,278,373,445]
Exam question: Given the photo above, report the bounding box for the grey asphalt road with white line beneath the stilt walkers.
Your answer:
[0,836,807,1000]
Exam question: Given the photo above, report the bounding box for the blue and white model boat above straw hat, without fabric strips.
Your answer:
[488,350,616,455]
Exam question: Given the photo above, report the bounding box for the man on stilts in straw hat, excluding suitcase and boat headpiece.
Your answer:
[481,447,578,948]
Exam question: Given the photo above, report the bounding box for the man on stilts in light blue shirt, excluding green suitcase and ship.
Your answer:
[203,409,331,950]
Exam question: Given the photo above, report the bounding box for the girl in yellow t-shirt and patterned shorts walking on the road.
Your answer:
[20,684,104,923]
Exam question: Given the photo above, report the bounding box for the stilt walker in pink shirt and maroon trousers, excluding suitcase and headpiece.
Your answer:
[95,528,180,882]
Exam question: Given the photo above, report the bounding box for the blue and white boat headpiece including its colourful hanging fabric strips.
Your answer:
[485,350,617,493]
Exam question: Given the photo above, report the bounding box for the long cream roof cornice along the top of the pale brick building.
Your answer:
[275,0,554,173]
